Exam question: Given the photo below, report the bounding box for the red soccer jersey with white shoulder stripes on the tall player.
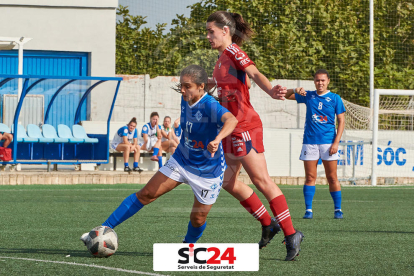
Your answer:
[213,43,262,133]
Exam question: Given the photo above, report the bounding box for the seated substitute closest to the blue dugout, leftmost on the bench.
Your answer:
[111,117,142,172]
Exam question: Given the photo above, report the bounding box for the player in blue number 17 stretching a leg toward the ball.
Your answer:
[81,65,237,245]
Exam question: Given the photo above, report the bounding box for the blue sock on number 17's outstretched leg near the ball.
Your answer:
[102,193,144,229]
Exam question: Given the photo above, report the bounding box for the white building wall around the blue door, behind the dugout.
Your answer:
[0,0,118,120]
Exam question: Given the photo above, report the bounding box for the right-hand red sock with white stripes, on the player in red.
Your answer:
[269,195,296,236]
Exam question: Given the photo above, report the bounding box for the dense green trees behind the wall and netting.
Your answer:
[117,0,414,105]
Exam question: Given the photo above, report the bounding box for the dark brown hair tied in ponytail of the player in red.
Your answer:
[207,11,253,46]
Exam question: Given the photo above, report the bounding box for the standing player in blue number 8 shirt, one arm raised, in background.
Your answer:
[286,69,346,219]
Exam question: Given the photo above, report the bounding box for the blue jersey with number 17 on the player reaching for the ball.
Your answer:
[173,93,229,178]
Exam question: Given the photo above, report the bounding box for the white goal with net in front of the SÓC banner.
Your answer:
[371,89,414,186]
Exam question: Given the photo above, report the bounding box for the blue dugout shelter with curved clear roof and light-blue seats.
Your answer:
[0,75,122,165]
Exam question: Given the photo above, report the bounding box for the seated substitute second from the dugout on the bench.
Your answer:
[139,112,162,168]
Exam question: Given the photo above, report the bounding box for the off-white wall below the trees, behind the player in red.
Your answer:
[112,75,315,128]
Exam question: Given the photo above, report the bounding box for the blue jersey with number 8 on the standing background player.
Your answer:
[295,91,346,144]
